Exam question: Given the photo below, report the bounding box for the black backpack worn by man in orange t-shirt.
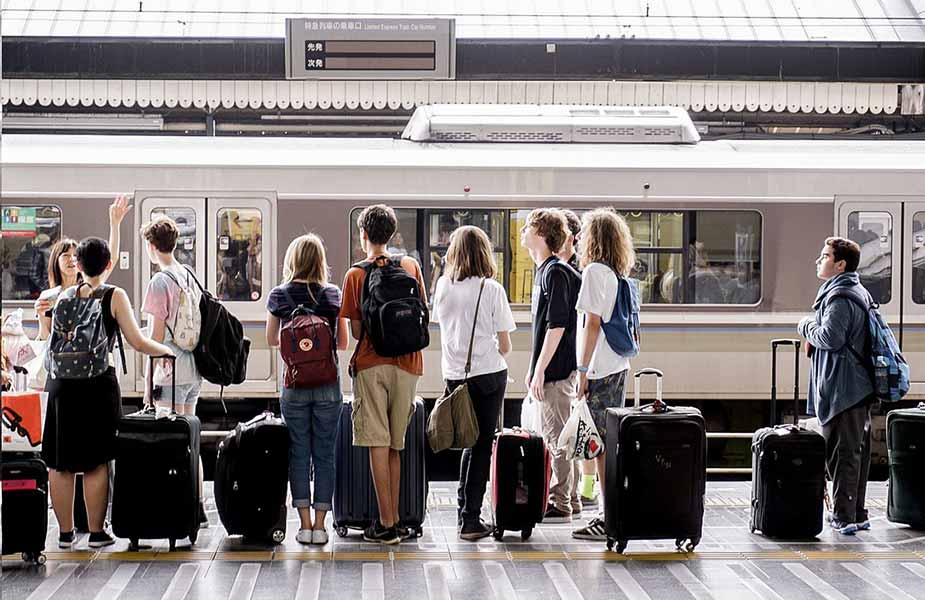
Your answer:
[353,256,430,364]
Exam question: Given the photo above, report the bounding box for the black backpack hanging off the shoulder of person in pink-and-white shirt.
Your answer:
[186,267,251,386]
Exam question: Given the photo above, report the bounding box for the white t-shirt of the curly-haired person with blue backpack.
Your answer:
[576,263,630,379]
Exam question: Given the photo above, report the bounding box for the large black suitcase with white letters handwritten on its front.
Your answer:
[604,369,707,553]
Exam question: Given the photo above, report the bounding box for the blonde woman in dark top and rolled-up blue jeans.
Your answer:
[266,233,347,545]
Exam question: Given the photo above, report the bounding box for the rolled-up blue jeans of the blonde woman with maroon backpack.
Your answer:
[280,381,344,510]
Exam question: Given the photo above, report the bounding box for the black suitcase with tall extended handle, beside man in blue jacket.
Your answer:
[749,340,825,538]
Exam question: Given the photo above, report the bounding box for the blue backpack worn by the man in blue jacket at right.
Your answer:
[830,288,909,402]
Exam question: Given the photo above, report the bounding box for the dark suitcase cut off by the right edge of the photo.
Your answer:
[886,403,925,529]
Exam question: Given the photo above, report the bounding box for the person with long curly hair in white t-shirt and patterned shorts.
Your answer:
[572,208,636,540]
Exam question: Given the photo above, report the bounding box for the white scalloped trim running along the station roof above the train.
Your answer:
[0,79,925,115]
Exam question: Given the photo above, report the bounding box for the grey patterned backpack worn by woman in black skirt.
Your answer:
[45,283,125,379]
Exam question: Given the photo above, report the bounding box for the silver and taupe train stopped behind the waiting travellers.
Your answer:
[0,108,925,472]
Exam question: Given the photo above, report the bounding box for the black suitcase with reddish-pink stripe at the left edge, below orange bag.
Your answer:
[0,453,48,565]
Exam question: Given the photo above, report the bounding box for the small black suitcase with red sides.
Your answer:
[491,424,552,541]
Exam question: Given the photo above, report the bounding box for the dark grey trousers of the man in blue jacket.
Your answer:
[822,400,870,523]
